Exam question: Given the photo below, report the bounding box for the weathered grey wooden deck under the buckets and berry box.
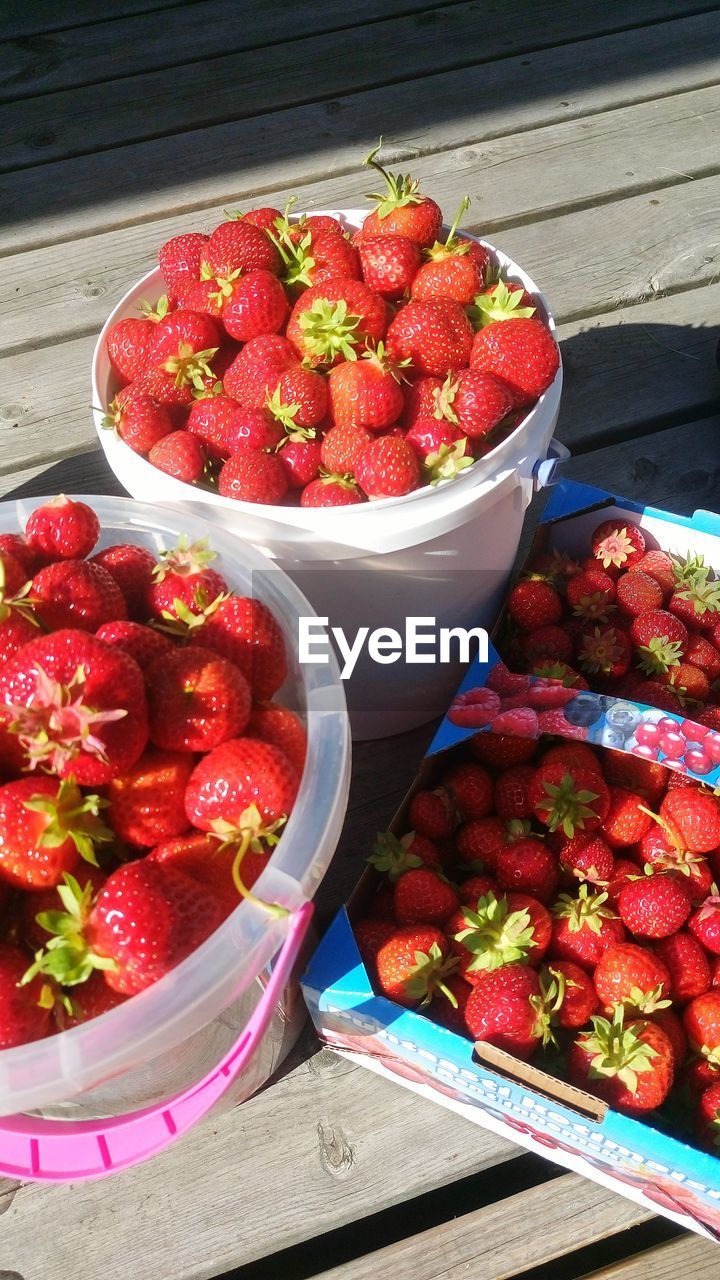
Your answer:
[0,0,720,1280]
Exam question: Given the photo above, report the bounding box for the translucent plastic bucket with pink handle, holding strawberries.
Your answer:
[0,497,350,1180]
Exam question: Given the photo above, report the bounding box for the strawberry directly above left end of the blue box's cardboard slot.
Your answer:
[465,964,543,1060]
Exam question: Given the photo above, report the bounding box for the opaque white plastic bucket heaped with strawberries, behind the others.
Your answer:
[92,209,565,739]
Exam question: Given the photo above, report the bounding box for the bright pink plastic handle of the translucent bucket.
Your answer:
[0,902,313,1183]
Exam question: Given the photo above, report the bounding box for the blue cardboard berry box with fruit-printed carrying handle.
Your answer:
[302,484,720,1240]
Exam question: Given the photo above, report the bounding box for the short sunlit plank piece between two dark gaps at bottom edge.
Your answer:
[308,1174,650,1280]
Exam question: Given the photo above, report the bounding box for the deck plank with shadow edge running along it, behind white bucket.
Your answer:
[0,13,720,252]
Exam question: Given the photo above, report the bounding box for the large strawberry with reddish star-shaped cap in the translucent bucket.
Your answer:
[0,630,147,786]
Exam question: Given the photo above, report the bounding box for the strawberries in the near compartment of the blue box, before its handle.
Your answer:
[354,732,720,1149]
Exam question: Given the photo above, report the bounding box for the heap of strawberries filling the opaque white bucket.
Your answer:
[105,148,560,507]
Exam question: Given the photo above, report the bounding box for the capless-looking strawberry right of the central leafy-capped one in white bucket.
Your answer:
[387,298,473,378]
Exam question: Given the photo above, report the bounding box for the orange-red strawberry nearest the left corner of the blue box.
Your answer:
[375,924,454,1009]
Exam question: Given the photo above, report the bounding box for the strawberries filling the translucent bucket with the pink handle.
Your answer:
[0,497,305,1048]
